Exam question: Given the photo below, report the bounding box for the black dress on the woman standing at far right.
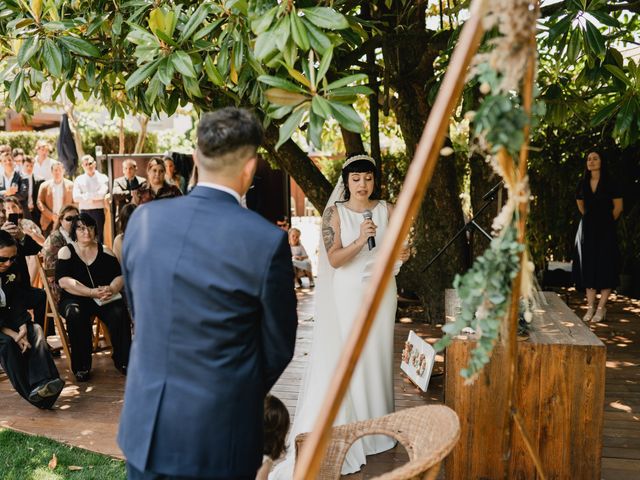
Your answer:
[573,178,622,290]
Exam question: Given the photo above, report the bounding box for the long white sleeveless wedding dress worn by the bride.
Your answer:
[269,201,397,480]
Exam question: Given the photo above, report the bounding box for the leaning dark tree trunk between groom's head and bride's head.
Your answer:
[264,124,333,212]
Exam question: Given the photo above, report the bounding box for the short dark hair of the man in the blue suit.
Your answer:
[196,107,264,172]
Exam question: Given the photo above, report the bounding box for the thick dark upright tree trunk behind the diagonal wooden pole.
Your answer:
[383,23,465,322]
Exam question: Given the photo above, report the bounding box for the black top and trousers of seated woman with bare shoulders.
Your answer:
[56,244,131,373]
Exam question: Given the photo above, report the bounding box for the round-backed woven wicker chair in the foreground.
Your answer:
[296,405,460,480]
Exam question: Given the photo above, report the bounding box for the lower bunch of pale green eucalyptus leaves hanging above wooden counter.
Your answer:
[435,223,524,380]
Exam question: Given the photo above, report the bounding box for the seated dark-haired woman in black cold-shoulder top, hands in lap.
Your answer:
[56,213,131,382]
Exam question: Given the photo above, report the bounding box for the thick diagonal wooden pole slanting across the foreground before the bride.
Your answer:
[294,0,486,480]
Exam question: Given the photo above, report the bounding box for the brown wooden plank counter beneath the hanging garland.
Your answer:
[445,290,606,480]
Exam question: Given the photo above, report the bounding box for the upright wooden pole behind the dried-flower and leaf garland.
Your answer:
[502,0,546,480]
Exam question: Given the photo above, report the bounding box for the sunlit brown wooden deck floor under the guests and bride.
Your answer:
[0,286,640,480]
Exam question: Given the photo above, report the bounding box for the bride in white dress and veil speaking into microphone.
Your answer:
[269,155,408,480]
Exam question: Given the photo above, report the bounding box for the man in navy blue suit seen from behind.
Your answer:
[118,108,297,480]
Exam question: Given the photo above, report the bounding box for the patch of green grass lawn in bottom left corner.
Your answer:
[0,429,127,480]
